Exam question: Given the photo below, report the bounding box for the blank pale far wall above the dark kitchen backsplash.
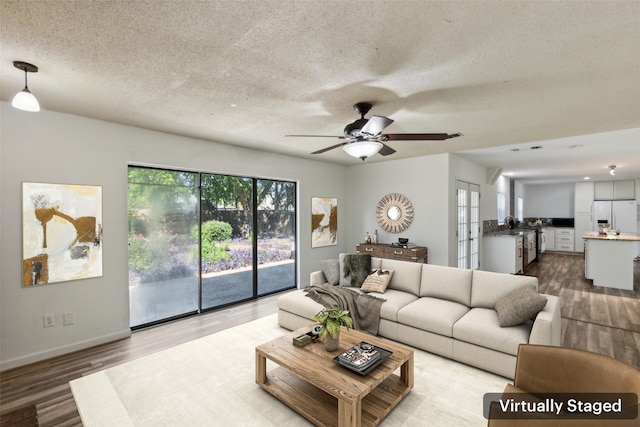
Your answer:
[524,183,575,218]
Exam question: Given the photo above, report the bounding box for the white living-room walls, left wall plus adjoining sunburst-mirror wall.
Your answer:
[0,102,495,370]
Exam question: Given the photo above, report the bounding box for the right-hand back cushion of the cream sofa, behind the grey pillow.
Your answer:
[471,270,538,309]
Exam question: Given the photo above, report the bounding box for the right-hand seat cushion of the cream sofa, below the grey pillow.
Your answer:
[453,308,533,356]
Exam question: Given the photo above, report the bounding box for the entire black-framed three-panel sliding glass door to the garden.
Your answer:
[129,166,296,327]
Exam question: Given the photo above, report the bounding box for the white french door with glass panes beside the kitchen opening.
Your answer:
[456,181,480,270]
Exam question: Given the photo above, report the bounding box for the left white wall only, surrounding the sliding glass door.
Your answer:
[0,102,353,369]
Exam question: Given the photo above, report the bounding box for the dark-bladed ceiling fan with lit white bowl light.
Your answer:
[285,102,462,161]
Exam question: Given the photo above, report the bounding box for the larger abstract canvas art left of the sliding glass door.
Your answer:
[22,182,102,287]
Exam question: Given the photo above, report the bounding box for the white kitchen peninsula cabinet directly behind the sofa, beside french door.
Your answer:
[480,234,524,274]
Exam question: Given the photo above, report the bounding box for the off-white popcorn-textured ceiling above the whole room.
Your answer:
[0,0,640,178]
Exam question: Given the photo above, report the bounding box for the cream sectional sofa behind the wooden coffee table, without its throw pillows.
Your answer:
[277,257,561,379]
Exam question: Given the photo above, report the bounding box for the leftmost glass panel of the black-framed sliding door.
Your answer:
[128,168,199,326]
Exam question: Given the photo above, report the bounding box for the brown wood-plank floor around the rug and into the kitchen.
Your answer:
[0,253,640,427]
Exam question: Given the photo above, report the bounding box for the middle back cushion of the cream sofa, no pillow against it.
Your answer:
[420,264,472,306]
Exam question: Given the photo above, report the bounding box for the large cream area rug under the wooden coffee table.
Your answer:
[70,314,509,427]
